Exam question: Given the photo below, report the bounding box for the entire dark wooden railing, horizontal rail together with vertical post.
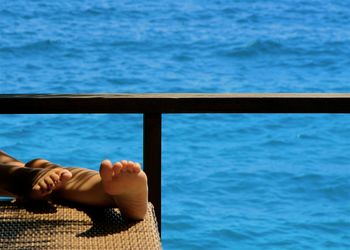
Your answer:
[0,94,350,232]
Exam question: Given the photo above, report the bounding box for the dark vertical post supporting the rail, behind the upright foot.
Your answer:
[143,113,162,234]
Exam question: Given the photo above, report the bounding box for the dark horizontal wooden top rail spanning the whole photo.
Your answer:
[0,94,350,114]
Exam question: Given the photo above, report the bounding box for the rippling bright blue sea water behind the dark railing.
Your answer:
[0,0,350,250]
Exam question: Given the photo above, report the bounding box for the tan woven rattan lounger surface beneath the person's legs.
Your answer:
[0,201,161,250]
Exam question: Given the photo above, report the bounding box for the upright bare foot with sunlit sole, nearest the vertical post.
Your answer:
[100,160,148,220]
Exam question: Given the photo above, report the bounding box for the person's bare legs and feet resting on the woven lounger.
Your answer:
[0,151,148,220]
